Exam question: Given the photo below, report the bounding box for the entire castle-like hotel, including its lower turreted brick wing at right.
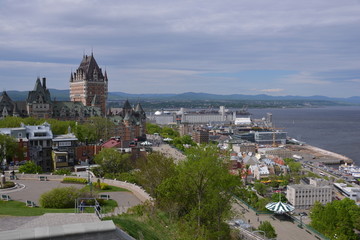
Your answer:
[0,54,146,145]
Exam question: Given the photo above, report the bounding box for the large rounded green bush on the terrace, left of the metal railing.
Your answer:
[39,187,80,208]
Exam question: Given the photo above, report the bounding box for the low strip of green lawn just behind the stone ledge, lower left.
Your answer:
[0,200,118,216]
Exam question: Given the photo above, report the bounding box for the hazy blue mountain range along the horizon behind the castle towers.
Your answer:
[7,89,360,104]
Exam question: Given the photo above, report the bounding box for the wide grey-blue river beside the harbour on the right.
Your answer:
[249,106,360,166]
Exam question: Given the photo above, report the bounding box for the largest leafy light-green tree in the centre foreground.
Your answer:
[158,146,239,238]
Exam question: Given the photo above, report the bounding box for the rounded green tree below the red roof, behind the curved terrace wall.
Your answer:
[95,148,132,174]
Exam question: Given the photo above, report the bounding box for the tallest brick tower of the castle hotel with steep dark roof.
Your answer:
[70,53,108,116]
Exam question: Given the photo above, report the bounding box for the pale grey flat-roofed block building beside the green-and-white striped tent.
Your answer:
[286,178,333,209]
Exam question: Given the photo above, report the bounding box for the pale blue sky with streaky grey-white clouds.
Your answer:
[0,0,360,97]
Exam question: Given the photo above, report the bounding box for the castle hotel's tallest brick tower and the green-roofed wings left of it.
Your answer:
[0,54,108,121]
